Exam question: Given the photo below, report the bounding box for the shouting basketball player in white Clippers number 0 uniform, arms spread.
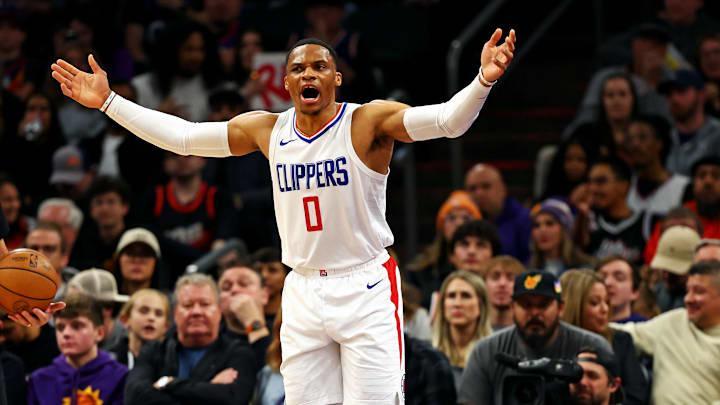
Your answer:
[52,29,515,405]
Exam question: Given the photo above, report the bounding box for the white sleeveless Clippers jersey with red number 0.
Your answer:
[268,103,393,270]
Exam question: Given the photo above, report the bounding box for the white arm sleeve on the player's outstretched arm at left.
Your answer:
[106,94,231,157]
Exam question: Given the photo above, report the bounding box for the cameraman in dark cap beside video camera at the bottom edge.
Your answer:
[568,349,625,405]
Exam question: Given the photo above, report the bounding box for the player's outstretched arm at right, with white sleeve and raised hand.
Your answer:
[369,28,515,142]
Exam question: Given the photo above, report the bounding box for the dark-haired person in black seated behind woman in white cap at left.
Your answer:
[70,177,130,269]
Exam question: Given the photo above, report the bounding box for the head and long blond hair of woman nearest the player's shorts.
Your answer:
[432,270,492,388]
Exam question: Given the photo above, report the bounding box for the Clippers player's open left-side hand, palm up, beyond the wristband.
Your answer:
[51,55,110,108]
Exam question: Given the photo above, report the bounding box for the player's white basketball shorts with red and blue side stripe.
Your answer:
[280,252,405,405]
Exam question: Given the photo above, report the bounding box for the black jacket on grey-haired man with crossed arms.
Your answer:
[125,334,256,405]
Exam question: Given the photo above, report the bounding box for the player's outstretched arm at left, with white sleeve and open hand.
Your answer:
[51,55,264,157]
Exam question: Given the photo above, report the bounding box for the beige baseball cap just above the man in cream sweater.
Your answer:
[650,225,700,276]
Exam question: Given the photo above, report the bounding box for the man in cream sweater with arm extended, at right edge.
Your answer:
[611,261,720,405]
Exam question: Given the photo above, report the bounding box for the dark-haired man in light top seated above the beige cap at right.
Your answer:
[627,116,690,240]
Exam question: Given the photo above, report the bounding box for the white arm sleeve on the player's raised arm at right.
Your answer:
[403,69,494,141]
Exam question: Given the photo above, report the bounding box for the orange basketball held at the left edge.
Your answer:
[0,249,60,314]
